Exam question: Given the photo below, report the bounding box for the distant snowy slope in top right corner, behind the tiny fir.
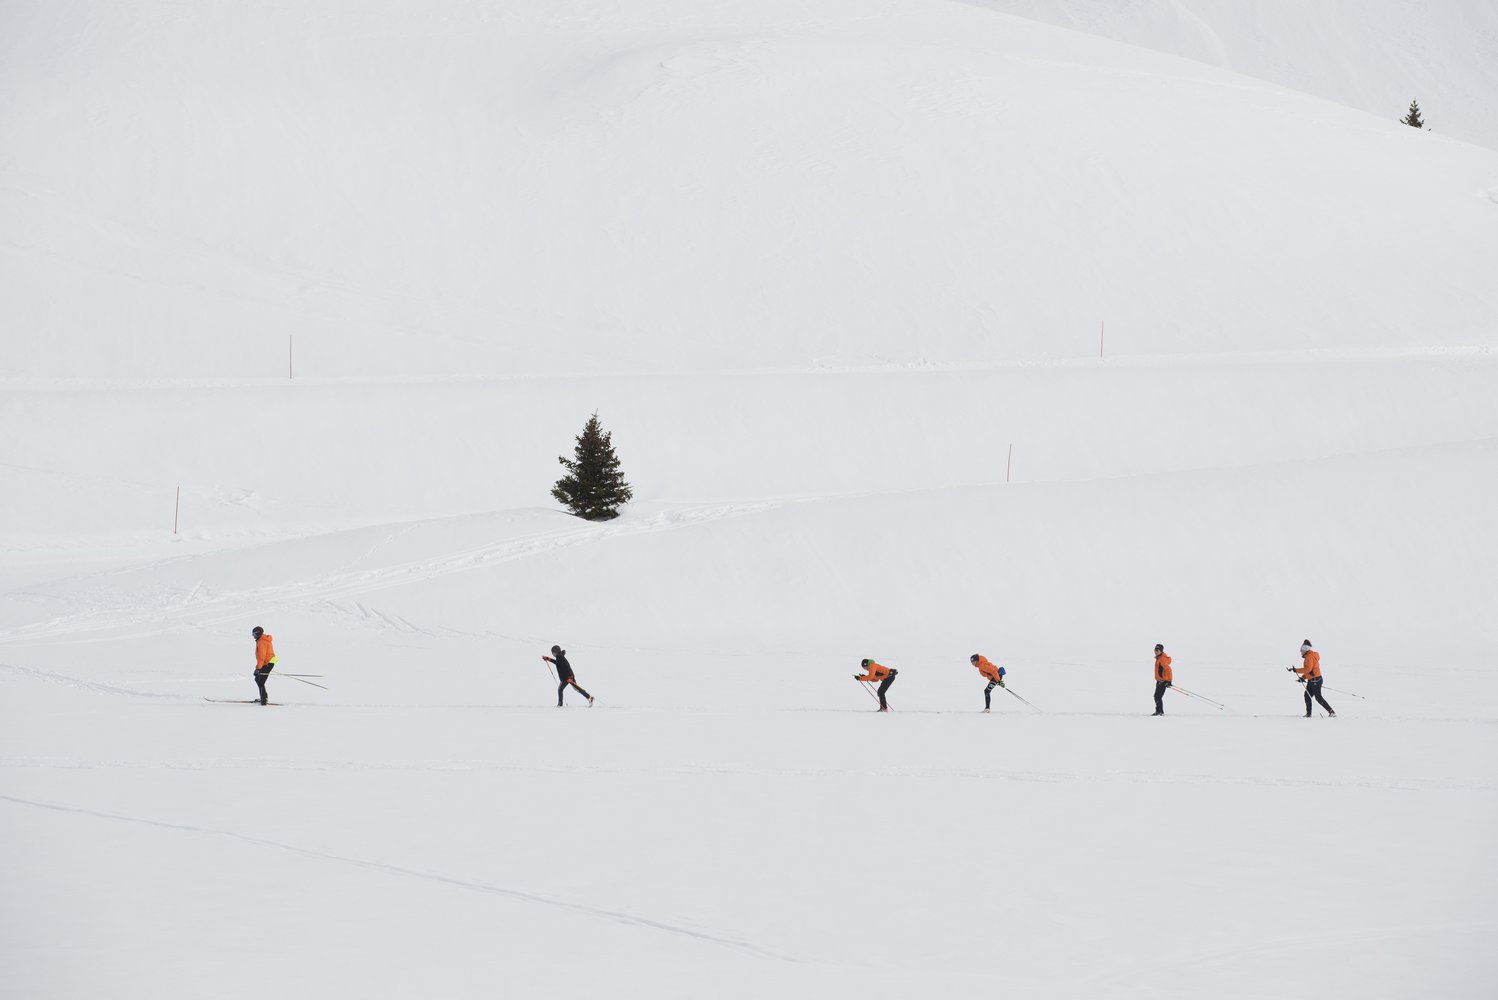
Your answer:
[963,0,1498,150]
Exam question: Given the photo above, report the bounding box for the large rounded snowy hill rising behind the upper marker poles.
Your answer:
[0,0,1498,377]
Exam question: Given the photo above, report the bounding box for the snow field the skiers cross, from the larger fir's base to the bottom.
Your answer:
[0,383,1498,997]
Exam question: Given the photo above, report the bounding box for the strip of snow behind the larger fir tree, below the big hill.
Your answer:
[0,344,1498,552]
